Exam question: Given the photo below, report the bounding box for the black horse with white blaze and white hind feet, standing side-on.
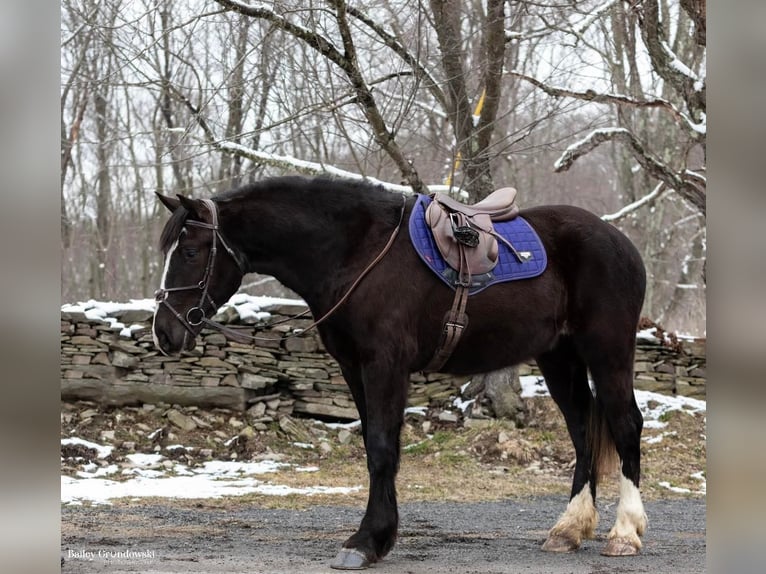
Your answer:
[153,177,646,569]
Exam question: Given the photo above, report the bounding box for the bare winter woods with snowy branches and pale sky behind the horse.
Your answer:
[61,0,705,336]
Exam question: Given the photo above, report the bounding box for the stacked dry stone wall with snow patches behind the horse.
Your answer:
[61,304,705,421]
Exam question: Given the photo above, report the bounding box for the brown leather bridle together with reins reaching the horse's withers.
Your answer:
[154,195,407,347]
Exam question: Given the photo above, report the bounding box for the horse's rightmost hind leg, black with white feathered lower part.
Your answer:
[588,333,647,556]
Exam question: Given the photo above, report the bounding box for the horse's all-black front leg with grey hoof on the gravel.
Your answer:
[331,365,409,570]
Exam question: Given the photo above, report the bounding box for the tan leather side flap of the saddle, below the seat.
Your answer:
[425,201,498,275]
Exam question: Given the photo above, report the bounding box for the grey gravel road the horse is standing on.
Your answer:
[61,497,706,574]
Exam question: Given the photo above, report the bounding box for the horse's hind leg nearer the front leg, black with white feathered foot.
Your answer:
[537,337,598,552]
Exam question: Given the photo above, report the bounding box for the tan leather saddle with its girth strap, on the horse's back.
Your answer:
[424,187,519,372]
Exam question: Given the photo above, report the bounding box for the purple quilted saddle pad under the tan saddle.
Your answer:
[409,194,548,295]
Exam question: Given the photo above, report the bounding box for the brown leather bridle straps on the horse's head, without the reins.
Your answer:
[154,199,246,347]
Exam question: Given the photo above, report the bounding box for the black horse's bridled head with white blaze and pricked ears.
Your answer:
[152,194,245,355]
